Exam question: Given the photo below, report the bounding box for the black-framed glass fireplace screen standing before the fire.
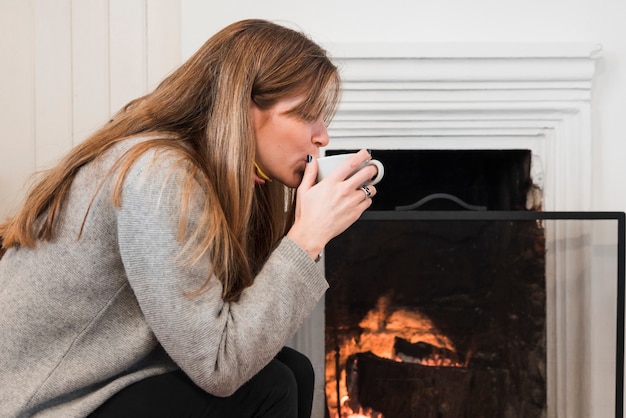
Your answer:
[324,211,624,418]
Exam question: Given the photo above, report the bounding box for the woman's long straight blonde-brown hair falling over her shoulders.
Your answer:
[0,19,340,301]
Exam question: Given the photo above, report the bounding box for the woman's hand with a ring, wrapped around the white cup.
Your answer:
[287,150,376,259]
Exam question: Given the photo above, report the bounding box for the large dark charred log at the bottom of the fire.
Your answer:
[346,353,508,418]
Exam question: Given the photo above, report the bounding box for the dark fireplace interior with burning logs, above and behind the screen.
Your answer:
[324,150,546,418]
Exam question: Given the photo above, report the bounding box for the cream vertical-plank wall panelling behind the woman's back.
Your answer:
[0,0,181,219]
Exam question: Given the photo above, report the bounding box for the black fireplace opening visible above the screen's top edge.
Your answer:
[326,149,541,211]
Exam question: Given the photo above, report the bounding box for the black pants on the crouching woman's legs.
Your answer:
[90,347,314,418]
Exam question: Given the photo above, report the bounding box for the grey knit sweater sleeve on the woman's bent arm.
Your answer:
[117,153,328,396]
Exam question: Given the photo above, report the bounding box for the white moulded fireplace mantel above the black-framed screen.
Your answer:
[326,43,601,210]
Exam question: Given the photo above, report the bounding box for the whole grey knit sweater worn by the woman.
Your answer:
[0,141,328,418]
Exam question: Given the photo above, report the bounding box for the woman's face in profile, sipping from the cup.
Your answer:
[250,97,329,187]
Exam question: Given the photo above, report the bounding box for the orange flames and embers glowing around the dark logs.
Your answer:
[326,296,460,418]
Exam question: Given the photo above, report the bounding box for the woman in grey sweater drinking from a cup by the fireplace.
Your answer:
[0,20,376,417]
